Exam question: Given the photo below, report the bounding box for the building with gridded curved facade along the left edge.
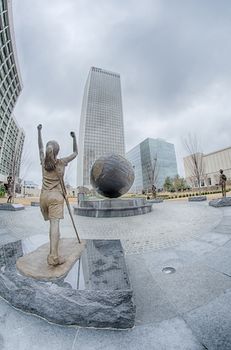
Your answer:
[0,0,25,182]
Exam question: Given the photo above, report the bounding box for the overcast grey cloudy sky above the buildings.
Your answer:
[13,0,231,185]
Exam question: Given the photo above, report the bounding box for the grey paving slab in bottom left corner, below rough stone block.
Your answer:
[0,298,77,350]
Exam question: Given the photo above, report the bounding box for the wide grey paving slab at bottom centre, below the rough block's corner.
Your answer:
[73,318,205,350]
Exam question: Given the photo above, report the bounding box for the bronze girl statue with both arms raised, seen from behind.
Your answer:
[37,124,78,266]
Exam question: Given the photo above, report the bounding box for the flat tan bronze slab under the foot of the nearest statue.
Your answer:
[16,238,85,281]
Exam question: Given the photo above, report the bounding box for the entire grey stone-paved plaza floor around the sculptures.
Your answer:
[0,201,231,350]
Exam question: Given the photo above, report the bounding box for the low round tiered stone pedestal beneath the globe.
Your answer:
[74,198,152,218]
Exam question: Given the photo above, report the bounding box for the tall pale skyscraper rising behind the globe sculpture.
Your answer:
[77,67,125,186]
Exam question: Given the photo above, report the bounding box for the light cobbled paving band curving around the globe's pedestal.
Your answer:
[0,202,222,254]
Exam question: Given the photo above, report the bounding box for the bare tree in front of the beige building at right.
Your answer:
[183,134,204,192]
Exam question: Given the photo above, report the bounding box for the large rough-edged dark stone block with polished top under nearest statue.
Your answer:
[0,236,135,329]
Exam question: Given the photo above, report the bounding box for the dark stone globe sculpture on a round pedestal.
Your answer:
[91,154,135,198]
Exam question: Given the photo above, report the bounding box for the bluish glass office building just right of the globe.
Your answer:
[126,138,177,192]
